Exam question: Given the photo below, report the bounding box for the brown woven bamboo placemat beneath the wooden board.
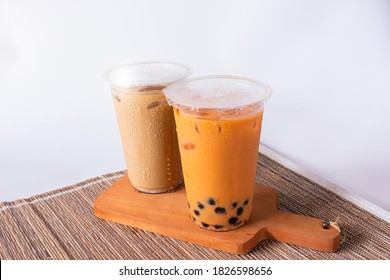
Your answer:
[0,154,390,260]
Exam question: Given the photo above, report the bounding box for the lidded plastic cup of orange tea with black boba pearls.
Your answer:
[164,76,271,231]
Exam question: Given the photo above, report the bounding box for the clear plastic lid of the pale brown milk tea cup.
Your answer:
[103,61,192,88]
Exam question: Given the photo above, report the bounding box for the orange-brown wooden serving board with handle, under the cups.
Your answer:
[94,174,340,254]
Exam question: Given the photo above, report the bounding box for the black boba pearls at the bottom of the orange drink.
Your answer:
[188,198,250,231]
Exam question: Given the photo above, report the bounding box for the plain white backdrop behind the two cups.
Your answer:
[0,0,390,210]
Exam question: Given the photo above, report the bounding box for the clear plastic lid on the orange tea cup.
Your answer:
[163,76,272,110]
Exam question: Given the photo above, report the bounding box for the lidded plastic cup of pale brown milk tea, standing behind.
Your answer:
[104,62,192,193]
